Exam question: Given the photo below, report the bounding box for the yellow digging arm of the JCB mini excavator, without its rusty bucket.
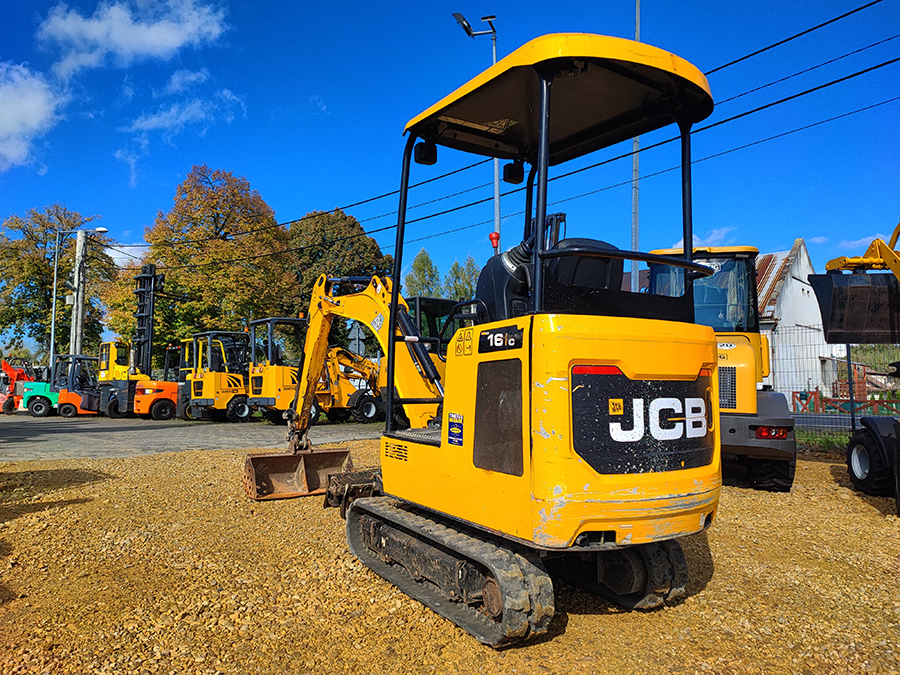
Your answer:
[288,274,444,452]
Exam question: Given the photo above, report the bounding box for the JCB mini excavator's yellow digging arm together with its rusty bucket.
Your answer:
[244,274,443,500]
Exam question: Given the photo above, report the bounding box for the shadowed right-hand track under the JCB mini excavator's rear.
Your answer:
[546,541,688,609]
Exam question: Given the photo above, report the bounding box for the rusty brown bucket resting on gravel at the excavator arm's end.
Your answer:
[244,448,353,500]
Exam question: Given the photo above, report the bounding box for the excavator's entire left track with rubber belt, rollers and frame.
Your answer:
[347,497,554,647]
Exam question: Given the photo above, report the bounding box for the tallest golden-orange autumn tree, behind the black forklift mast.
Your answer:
[106,165,296,353]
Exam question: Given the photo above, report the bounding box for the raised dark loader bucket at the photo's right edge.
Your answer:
[809,272,900,344]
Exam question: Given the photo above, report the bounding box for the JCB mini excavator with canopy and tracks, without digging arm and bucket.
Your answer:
[250,34,721,647]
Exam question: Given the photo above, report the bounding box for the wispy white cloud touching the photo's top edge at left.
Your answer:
[38,0,226,80]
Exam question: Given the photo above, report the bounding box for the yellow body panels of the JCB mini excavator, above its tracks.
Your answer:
[381,315,721,548]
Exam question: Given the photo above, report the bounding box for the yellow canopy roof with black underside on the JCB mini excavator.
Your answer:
[406,33,713,164]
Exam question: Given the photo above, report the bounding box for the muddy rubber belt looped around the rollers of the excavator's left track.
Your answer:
[347,497,554,647]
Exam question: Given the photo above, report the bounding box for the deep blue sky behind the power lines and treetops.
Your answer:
[0,0,900,282]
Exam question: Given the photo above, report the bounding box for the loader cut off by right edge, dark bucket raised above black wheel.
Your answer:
[809,224,900,515]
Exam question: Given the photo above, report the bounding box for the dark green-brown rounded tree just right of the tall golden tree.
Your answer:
[290,209,394,312]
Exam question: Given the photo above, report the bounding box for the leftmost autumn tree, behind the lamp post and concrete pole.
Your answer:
[0,204,115,354]
